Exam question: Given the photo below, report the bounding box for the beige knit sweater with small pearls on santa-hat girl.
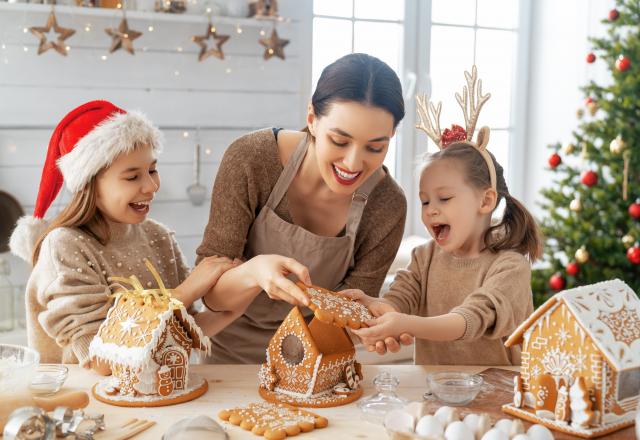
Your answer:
[26,220,189,365]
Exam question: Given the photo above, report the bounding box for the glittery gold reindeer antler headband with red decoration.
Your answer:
[416,66,497,192]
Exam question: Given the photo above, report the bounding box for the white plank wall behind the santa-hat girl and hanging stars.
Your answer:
[0,0,312,290]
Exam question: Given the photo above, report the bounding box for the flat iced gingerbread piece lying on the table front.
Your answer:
[218,403,329,440]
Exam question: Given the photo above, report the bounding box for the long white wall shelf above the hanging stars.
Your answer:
[0,1,297,27]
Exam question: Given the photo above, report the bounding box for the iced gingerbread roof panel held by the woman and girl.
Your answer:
[297,282,373,329]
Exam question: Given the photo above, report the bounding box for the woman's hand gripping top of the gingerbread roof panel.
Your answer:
[245,255,311,306]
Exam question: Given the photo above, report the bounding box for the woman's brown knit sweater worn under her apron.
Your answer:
[196,128,407,296]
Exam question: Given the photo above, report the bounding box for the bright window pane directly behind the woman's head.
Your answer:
[312,0,405,176]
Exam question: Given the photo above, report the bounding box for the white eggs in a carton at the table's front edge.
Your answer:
[384,402,553,440]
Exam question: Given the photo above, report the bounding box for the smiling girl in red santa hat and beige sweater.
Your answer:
[11,101,238,372]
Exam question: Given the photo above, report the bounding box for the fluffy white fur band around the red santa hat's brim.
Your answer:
[58,111,162,193]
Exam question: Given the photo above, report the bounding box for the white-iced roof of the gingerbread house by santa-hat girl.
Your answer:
[89,293,211,368]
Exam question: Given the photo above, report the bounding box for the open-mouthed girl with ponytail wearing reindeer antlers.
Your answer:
[348,66,541,365]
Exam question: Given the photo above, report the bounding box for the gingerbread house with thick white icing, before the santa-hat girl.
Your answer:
[89,264,211,406]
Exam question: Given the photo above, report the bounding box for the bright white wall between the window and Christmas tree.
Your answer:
[524,0,615,215]
